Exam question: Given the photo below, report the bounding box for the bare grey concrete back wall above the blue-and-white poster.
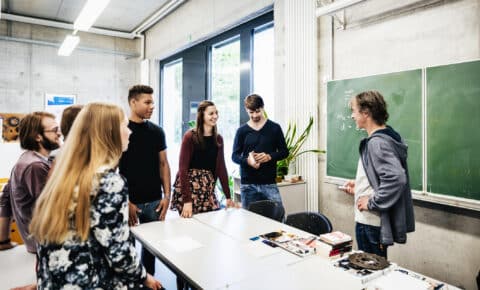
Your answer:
[0,21,140,113]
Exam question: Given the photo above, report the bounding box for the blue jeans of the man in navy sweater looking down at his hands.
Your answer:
[240,184,283,209]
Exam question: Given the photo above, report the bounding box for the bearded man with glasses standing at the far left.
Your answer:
[0,112,61,253]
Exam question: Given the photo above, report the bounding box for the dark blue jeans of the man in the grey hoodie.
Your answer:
[355,223,388,259]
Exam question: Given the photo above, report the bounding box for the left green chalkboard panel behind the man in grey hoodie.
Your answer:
[327,69,422,190]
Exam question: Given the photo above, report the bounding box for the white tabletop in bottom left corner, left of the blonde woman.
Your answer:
[0,245,37,289]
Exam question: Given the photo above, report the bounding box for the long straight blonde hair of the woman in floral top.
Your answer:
[30,103,125,244]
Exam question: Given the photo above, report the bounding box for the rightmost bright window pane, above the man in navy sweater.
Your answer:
[253,24,275,120]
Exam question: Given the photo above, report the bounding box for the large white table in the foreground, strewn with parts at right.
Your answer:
[131,209,455,290]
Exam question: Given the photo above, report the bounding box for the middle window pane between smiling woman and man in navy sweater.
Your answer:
[210,36,240,173]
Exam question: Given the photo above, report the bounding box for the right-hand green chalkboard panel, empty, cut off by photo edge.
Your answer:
[426,61,480,200]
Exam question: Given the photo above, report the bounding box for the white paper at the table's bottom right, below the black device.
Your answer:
[368,271,430,290]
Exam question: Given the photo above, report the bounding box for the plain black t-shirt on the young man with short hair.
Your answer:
[120,121,167,204]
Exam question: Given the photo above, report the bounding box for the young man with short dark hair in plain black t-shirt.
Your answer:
[120,85,171,275]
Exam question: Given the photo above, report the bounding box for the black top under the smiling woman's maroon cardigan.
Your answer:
[190,136,218,175]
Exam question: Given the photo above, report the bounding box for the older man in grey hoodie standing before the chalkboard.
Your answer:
[344,91,415,258]
